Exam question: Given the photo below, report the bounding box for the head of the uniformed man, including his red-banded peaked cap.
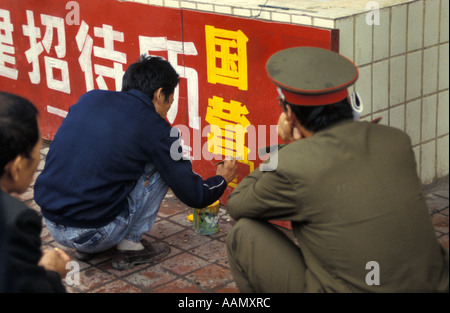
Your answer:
[267,47,358,133]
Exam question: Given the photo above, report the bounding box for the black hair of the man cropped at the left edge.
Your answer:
[0,92,40,176]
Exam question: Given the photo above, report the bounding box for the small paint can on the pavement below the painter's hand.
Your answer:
[193,200,220,235]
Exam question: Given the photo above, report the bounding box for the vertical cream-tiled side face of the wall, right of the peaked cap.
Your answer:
[335,0,449,183]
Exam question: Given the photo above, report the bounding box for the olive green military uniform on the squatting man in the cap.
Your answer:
[227,47,449,292]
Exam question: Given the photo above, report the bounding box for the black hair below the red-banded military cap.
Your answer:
[288,98,353,132]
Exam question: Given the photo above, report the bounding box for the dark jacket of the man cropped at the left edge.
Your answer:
[0,191,66,293]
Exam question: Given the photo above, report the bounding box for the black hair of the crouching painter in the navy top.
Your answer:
[122,55,180,100]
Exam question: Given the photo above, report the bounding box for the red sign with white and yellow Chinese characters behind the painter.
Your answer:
[0,0,337,202]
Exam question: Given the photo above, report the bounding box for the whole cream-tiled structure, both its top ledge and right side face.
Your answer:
[121,0,449,183]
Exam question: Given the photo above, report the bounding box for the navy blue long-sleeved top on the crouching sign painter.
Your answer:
[35,90,227,228]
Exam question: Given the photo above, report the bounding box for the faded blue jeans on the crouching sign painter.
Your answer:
[45,163,168,253]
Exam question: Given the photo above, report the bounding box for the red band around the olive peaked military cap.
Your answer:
[283,88,348,105]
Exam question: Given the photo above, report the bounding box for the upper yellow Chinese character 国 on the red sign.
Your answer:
[205,25,248,90]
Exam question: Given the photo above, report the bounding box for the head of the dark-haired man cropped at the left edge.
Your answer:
[0,92,42,194]
